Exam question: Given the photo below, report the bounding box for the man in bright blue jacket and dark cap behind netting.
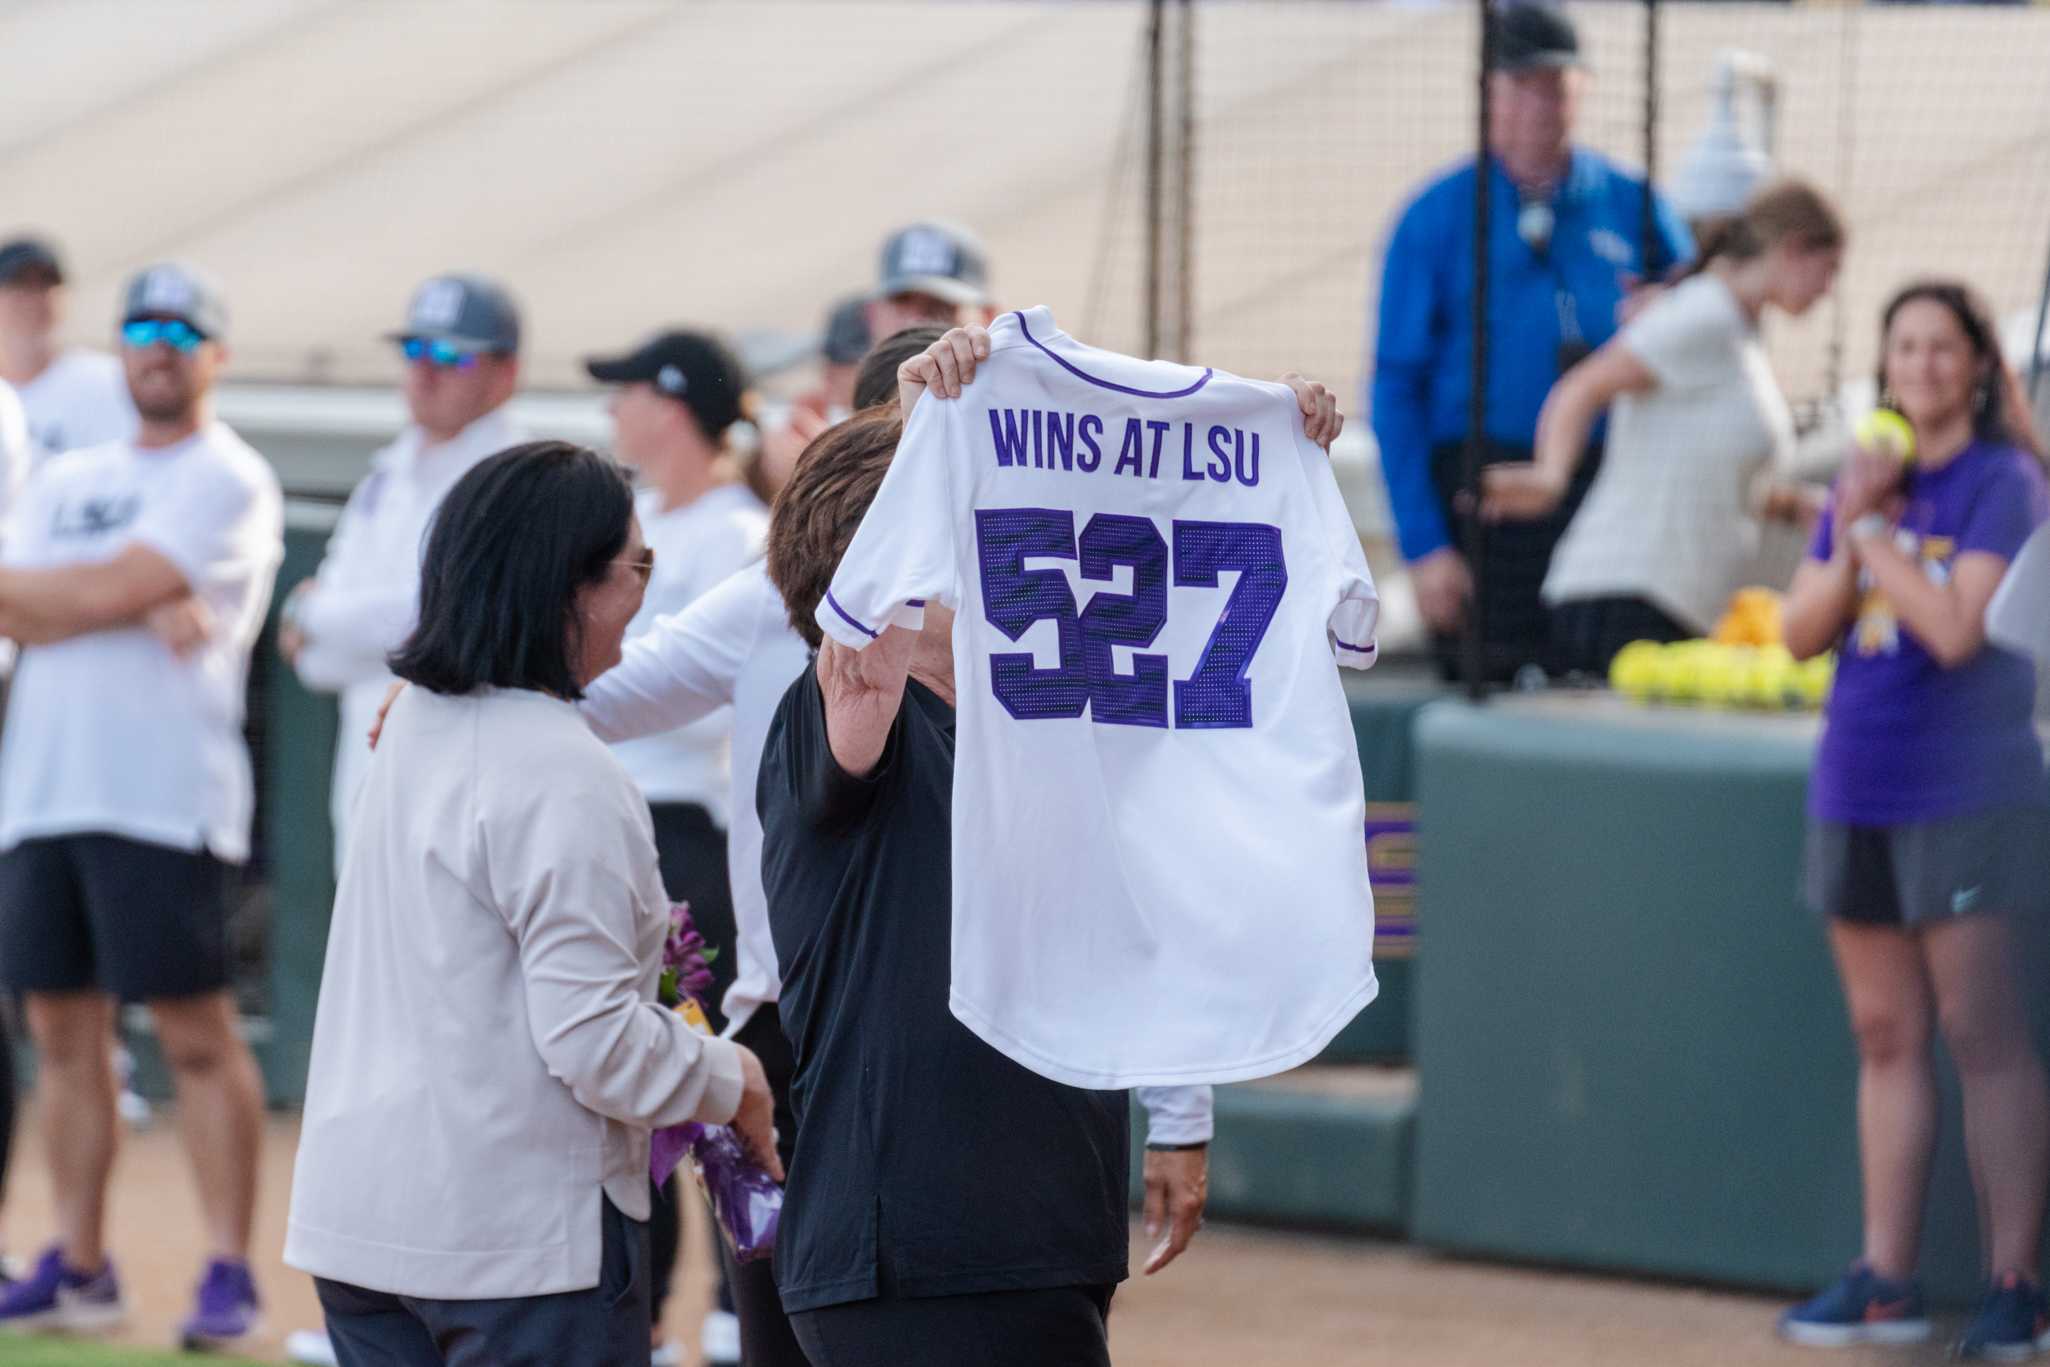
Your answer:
[1369,4,1693,680]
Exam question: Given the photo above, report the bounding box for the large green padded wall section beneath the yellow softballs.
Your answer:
[1412,699,2050,1299]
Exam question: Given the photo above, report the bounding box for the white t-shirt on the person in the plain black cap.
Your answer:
[613,484,770,828]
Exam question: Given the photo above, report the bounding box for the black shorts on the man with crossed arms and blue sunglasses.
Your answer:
[0,834,232,1002]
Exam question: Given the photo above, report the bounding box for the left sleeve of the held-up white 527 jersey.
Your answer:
[816,396,961,650]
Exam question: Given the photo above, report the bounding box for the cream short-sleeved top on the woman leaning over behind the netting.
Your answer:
[1544,275,1794,635]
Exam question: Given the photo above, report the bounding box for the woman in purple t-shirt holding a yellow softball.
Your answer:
[1779,281,2050,1361]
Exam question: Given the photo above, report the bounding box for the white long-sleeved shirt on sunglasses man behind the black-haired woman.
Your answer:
[293,408,527,869]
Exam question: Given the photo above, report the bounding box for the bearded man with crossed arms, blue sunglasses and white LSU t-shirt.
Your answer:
[0,264,285,1347]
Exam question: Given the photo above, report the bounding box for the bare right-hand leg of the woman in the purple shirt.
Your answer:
[1923,916,2050,1281]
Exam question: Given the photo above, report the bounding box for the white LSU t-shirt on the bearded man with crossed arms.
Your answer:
[0,422,285,863]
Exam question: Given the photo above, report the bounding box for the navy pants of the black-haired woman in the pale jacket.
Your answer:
[314,1201,650,1367]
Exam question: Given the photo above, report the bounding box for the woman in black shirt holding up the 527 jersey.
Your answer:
[756,401,1130,1367]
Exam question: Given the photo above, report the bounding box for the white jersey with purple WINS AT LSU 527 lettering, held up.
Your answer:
[818,307,1380,1088]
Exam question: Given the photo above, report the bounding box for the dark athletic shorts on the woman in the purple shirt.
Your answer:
[1802,805,2050,926]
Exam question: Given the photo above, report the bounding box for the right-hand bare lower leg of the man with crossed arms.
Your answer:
[150,992,262,1258]
